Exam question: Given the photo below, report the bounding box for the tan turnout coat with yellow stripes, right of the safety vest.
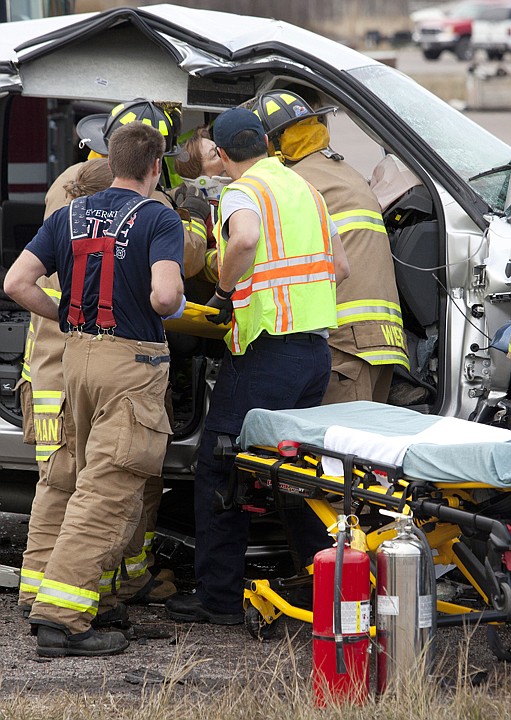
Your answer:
[292,152,409,402]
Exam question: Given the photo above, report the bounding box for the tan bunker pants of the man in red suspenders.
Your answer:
[30,334,171,633]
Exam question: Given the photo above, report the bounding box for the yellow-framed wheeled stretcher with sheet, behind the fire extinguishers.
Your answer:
[224,402,511,659]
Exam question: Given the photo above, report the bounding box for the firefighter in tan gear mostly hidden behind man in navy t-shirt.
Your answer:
[19,159,143,624]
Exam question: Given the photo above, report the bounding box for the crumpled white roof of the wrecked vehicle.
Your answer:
[0,4,376,100]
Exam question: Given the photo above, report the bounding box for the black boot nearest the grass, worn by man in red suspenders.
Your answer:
[37,623,129,657]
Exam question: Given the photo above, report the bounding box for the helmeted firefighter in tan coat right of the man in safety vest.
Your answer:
[252,90,410,404]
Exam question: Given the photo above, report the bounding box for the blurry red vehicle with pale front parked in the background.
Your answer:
[415,0,508,60]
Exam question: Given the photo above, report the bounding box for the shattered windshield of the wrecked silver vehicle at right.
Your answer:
[350,65,511,212]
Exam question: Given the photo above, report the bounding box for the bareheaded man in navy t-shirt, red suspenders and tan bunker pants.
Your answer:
[4,121,183,657]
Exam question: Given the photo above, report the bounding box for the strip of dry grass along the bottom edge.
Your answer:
[0,637,511,720]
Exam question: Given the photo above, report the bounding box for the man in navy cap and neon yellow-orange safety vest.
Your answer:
[166,108,349,625]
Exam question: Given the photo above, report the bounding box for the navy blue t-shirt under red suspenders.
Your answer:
[26,188,184,342]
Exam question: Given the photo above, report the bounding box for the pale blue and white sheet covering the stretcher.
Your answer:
[239,401,511,488]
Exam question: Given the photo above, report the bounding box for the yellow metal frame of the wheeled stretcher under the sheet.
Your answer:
[235,445,511,639]
